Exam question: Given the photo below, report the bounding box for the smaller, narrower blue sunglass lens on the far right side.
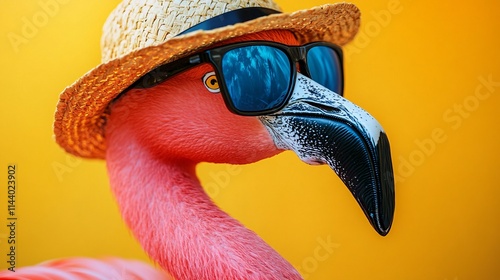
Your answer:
[307,46,342,95]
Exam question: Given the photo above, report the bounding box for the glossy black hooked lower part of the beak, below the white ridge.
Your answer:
[258,113,394,236]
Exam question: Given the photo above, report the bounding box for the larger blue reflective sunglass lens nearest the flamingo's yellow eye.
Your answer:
[221,46,292,113]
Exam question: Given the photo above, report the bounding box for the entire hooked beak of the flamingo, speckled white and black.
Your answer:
[260,73,394,236]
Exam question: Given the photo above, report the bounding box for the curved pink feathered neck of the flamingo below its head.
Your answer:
[106,132,302,279]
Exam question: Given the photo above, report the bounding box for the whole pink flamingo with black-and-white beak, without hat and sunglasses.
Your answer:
[0,31,394,279]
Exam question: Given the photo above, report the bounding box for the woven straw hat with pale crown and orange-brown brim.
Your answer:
[54,0,360,158]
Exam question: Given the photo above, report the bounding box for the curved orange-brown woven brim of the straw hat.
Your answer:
[54,3,360,159]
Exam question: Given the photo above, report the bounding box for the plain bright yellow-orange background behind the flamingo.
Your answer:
[0,0,500,280]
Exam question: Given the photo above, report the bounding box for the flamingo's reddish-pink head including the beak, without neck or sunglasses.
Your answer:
[107,31,394,235]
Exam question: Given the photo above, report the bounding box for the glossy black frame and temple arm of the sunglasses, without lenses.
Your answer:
[128,41,344,116]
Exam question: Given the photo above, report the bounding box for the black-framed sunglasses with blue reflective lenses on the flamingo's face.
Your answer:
[131,41,343,116]
